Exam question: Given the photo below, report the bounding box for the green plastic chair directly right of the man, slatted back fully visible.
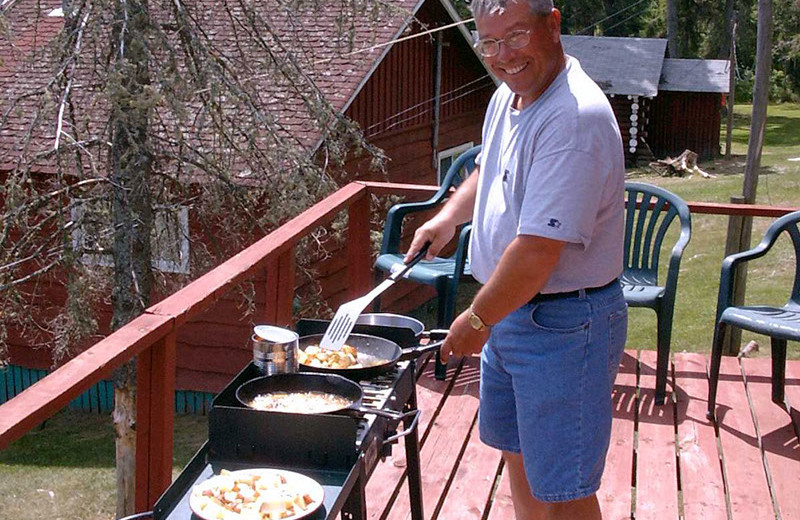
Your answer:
[620,182,692,404]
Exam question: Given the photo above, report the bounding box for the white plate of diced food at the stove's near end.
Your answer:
[189,468,325,520]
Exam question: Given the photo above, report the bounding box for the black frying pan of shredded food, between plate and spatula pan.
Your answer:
[236,373,416,421]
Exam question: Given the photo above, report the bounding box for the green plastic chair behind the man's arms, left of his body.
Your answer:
[375,145,481,328]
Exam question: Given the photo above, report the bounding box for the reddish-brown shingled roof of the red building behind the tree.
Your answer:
[0,0,450,175]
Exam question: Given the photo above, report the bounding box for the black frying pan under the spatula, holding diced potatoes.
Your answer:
[298,334,443,380]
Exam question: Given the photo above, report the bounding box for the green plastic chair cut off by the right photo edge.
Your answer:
[707,211,800,419]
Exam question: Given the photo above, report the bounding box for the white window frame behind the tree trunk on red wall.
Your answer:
[71,205,189,274]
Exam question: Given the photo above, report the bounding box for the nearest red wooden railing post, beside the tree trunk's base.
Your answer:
[136,331,177,511]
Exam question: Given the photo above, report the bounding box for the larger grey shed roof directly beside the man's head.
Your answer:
[561,34,667,97]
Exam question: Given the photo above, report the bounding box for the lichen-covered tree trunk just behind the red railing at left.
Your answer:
[109,0,153,517]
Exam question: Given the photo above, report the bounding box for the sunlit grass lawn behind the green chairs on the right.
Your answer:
[628,104,800,359]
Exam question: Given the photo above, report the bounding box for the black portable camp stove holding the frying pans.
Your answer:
[153,320,432,520]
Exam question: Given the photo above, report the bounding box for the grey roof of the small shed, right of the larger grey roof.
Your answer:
[658,58,730,94]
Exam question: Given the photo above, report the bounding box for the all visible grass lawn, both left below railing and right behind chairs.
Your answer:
[0,104,800,520]
